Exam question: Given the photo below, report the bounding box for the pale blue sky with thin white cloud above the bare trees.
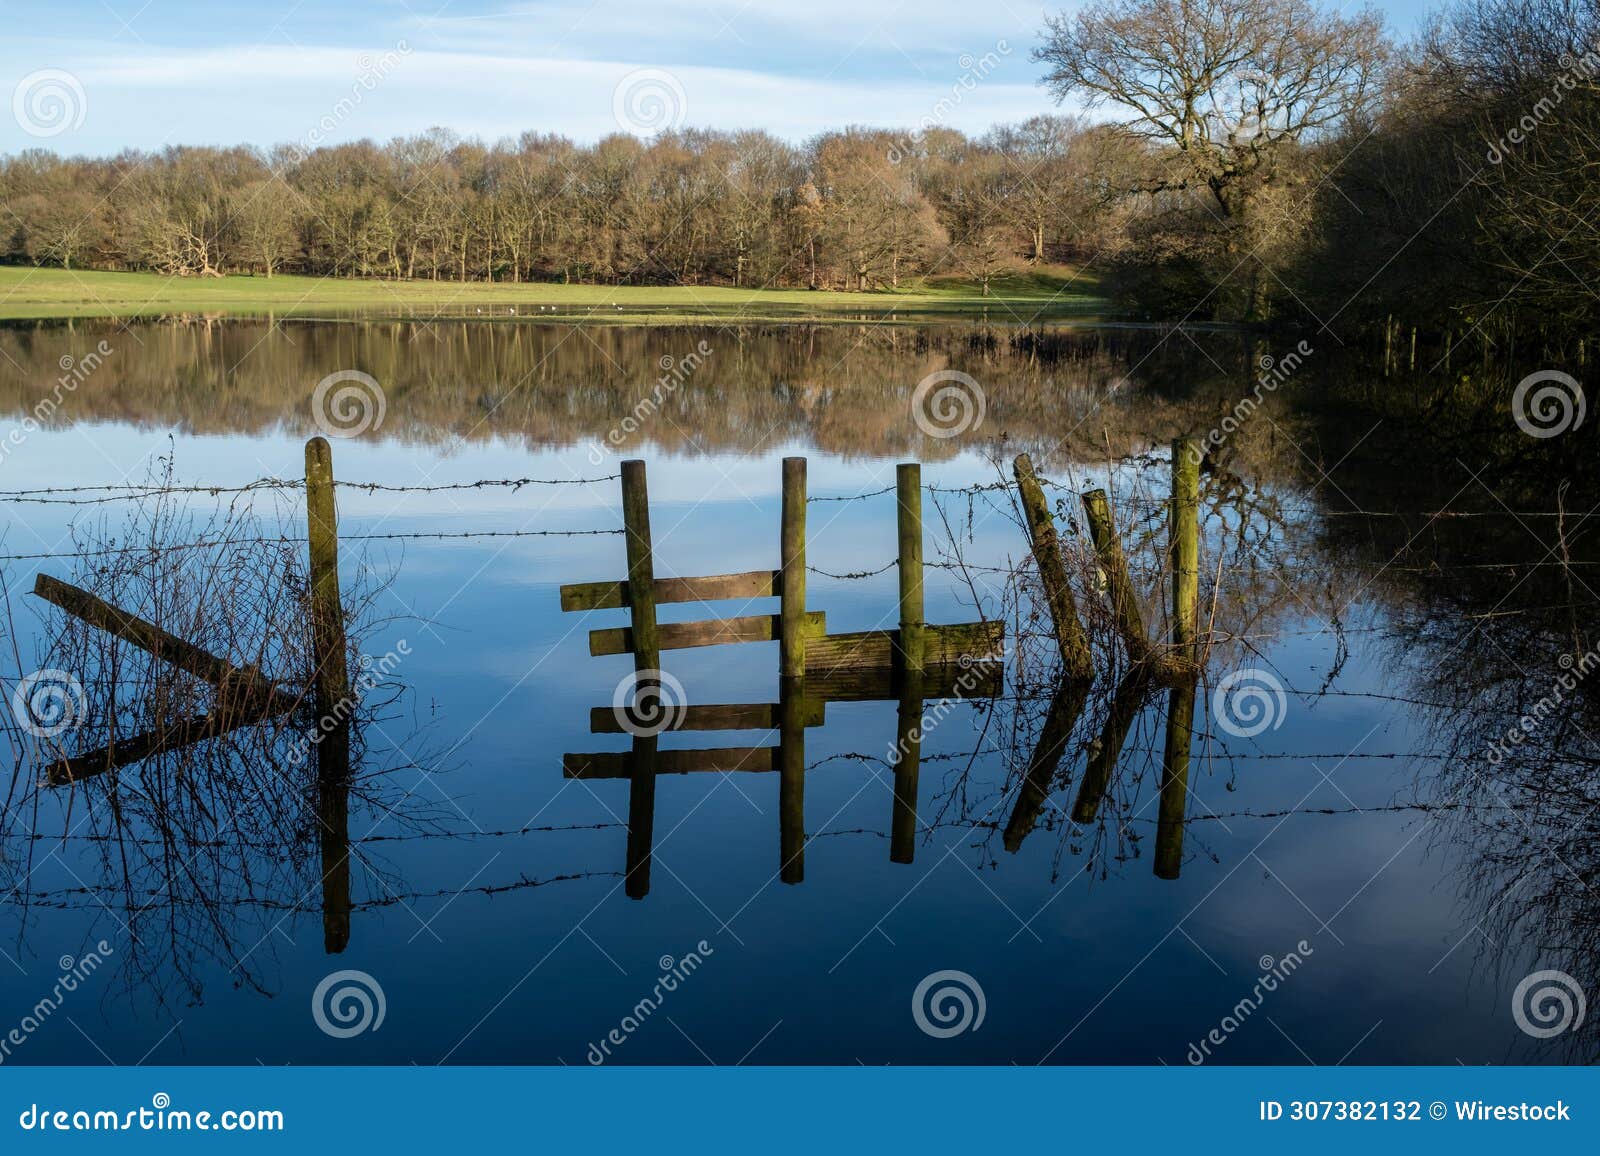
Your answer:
[0,0,1427,154]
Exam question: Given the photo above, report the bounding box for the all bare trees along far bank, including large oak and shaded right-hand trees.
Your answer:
[0,0,1600,343]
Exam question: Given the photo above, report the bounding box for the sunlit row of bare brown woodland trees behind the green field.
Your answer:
[0,115,1128,290]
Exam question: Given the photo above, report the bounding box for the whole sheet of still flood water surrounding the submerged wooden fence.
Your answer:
[0,319,1600,1065]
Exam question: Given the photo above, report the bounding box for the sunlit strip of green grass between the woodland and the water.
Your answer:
[0,266,1104,323]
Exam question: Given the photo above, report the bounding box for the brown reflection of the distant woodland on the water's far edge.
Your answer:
[0,319,1273,468]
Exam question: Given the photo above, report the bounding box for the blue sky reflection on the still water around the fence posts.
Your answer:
[0,424,1539,1063]
